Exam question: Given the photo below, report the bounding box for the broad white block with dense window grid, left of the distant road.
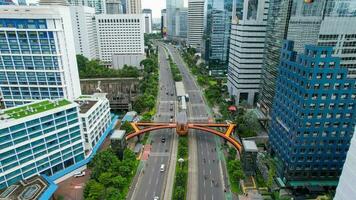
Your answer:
[96,14,145,69]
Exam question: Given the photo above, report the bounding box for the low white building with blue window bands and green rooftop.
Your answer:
[0,99,85,189]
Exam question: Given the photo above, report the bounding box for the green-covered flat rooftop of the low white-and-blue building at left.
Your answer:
[0,99,71,119]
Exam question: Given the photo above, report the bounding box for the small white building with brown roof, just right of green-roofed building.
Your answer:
[75,93,111,154]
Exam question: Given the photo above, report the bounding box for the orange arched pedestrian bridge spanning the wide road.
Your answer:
[126,112,242,153]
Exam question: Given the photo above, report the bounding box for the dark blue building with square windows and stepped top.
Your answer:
[269,41,356,184]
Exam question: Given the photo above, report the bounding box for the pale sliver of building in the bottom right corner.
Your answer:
[334,127,356,200]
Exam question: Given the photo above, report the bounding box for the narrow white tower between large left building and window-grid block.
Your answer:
[70,6,99,60]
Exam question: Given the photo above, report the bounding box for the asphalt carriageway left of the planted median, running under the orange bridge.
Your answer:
[132,47,176,200]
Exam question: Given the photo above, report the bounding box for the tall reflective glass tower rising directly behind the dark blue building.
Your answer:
[258,0,356,116]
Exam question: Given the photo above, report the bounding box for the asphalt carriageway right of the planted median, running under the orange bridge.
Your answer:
[166,45,225,200]
